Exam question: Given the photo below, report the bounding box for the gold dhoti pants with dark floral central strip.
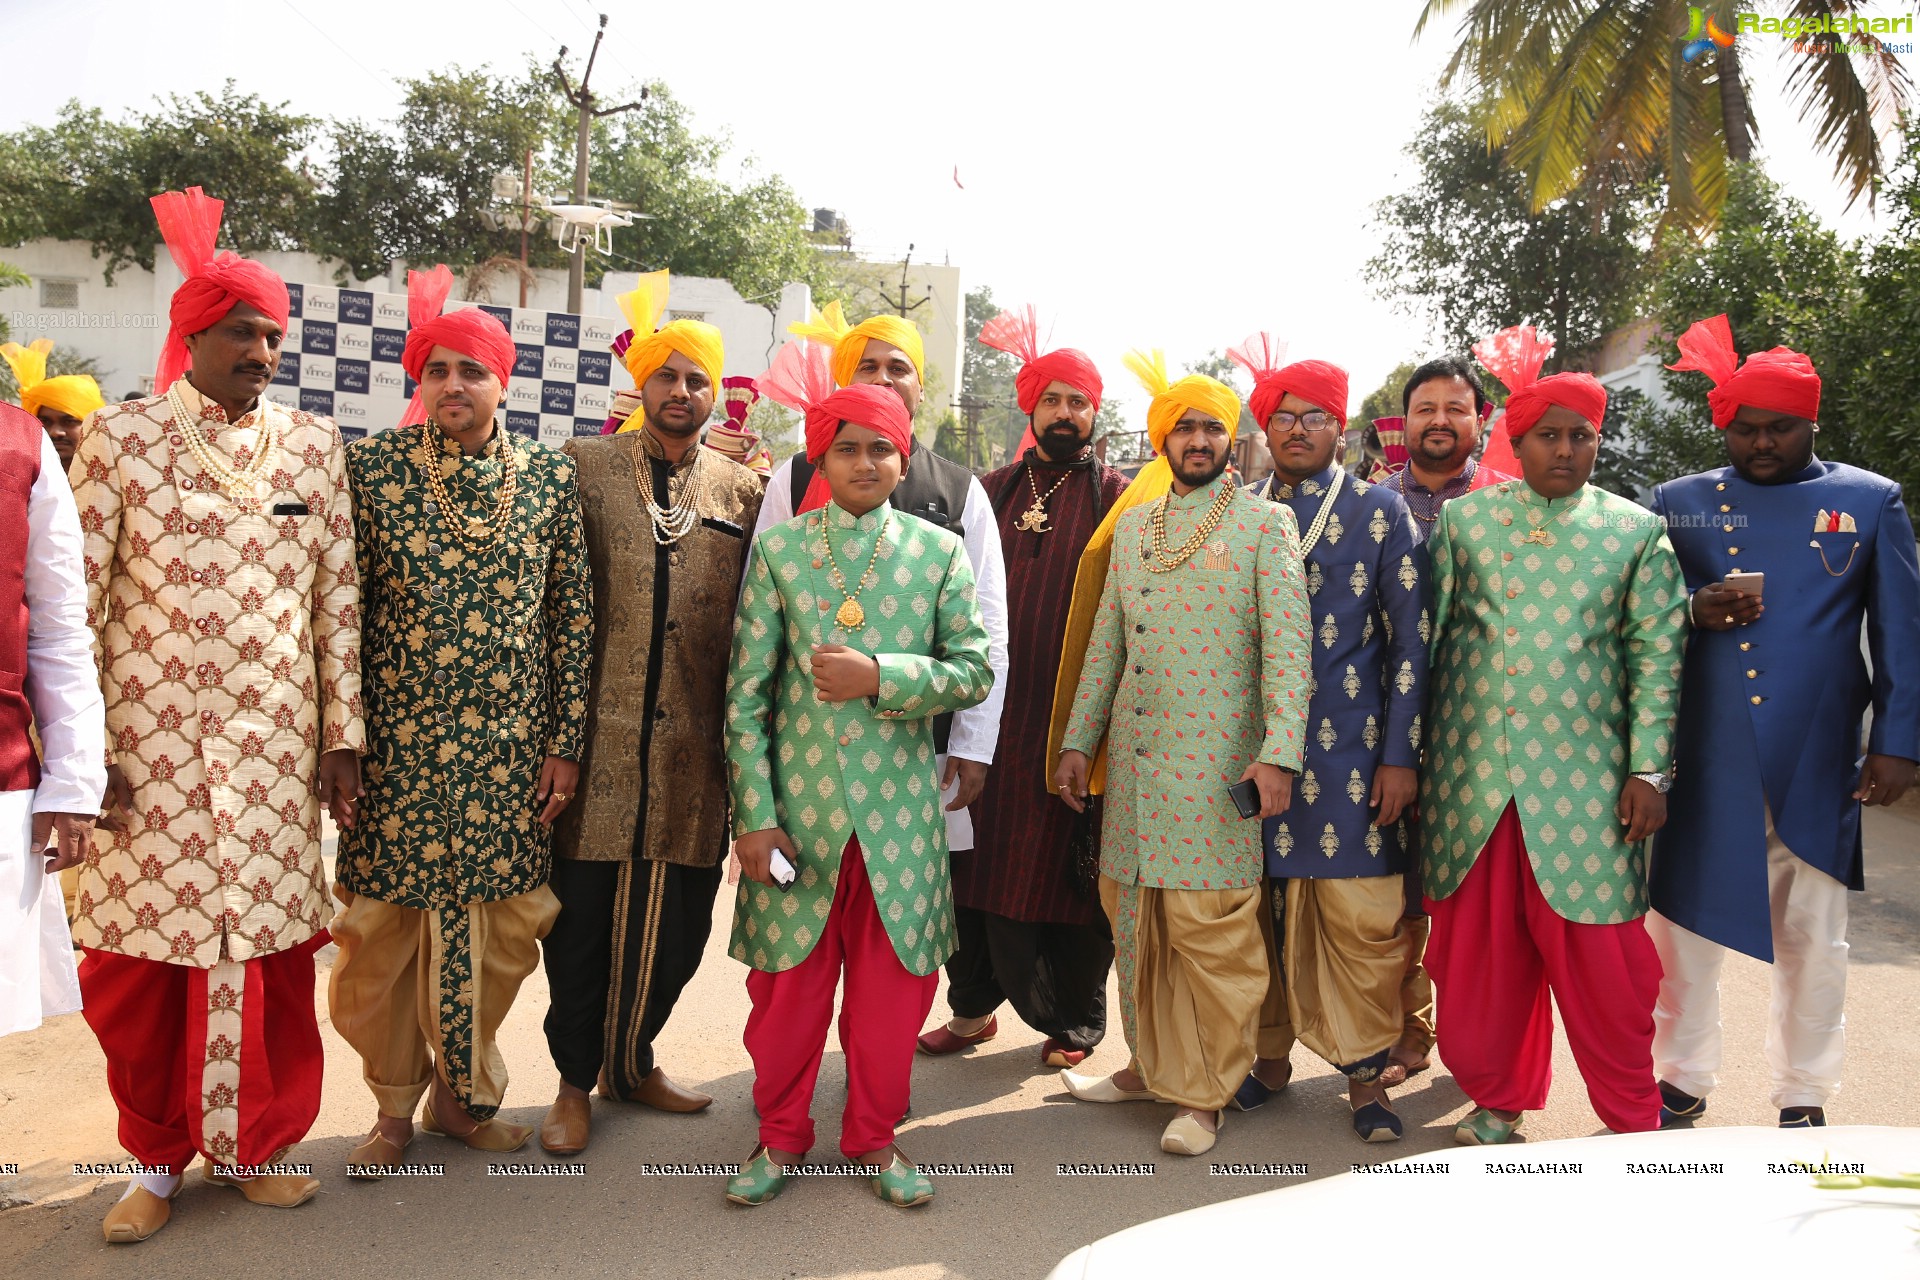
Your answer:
[326,885,561,1121]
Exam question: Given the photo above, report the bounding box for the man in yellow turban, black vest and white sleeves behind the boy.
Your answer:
[749,303,1006,867]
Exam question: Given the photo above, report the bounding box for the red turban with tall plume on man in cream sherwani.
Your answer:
[150,186,292,393]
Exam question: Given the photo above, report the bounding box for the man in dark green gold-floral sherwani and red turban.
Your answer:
[328,282,593,1178]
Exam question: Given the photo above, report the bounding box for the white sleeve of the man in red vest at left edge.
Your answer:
[25,436,108,816]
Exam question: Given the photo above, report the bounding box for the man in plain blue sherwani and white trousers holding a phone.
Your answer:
[1649,315,1920,1128]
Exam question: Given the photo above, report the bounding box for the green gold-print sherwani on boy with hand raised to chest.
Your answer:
[726,503,993,977]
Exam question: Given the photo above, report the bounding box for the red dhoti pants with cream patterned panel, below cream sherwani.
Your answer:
[81,933,328,1173]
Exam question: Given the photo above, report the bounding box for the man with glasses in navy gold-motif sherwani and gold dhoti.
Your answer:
[1233,345,1430,1142]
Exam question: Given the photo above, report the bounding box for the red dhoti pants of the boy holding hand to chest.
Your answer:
[745,841,941,1159]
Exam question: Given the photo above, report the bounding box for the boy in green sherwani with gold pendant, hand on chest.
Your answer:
[728,344,993,1205]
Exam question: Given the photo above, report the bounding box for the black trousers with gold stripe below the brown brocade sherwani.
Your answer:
[541,858,722,1100]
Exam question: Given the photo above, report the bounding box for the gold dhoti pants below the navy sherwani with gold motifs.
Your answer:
[1260,875,1407,1067]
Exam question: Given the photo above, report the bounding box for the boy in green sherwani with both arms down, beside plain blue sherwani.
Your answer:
[1421,328,1686,1144]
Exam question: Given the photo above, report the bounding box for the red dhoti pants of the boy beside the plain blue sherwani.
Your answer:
[1427,802,1661,1134]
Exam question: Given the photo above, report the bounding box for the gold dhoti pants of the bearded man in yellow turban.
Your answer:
[1100,875,1267,1111]
